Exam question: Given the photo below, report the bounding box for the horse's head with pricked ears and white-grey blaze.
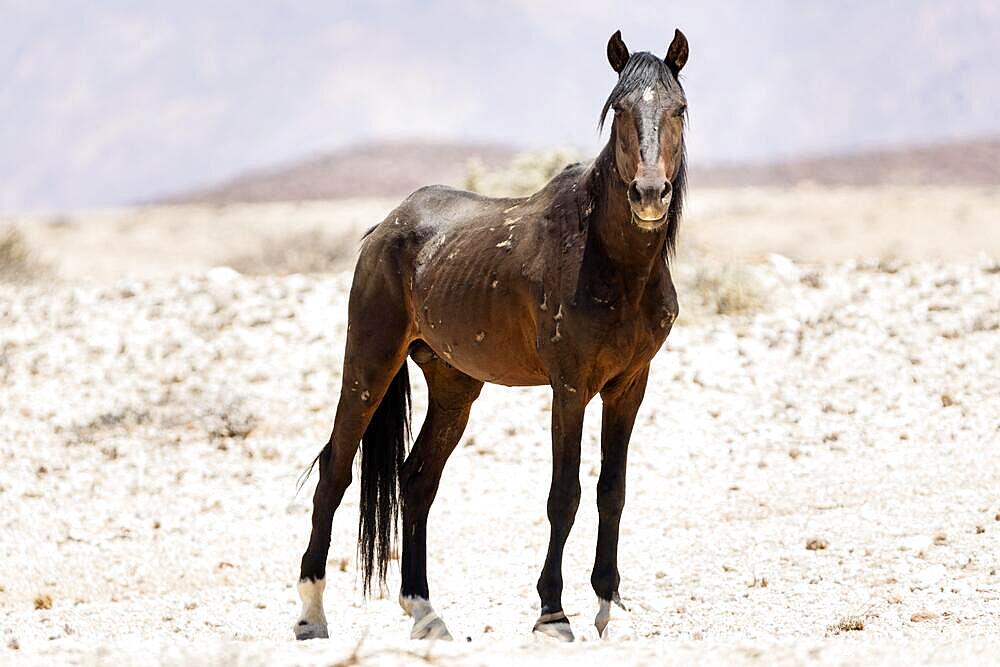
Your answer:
[601,30,688,231]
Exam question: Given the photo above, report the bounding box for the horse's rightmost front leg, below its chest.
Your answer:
[590,366,649,637]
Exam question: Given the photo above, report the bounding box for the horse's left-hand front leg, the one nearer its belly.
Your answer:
[534,383,587,641]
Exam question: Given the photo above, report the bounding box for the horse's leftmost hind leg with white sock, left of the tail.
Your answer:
[294,264,409,639]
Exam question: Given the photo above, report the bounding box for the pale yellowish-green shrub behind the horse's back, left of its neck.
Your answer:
[463,148,580,197]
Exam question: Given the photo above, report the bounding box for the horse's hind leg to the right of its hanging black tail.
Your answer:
[399,347,483,639]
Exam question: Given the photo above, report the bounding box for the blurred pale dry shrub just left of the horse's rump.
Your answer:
[226,229,360,276]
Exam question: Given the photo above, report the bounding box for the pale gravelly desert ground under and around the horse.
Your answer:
[0,190,1000,665]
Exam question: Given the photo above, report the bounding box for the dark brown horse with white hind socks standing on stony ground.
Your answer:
[295,31,688,640]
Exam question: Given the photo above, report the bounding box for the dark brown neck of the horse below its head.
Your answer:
[588,147,667,300]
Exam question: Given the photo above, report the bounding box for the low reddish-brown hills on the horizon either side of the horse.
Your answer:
[157,139,1000,204]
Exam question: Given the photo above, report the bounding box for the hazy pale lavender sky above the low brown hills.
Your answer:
[0,0,1000,210]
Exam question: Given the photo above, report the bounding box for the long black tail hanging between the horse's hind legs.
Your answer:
[358,361,410,593]
